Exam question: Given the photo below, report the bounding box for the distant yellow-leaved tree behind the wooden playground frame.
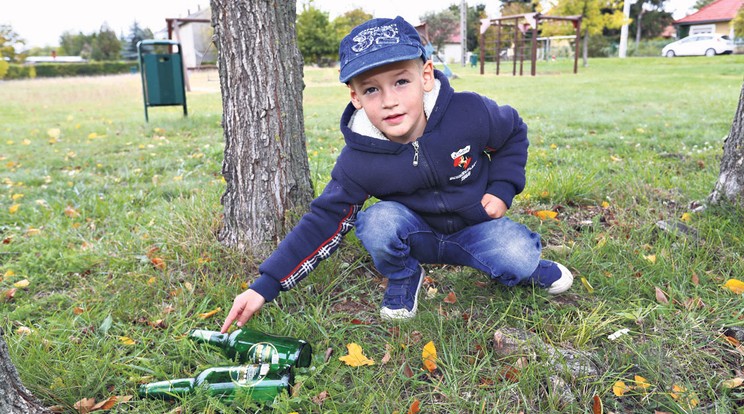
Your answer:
[542,0,625,66]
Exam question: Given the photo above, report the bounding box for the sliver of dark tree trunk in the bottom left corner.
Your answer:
[0,328,51,414]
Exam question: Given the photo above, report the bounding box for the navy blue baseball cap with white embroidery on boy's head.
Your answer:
[338,16,426,83]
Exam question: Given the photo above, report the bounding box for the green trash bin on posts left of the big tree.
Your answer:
[137,40,188,121]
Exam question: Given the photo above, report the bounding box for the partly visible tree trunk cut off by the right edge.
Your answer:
[708,84,744,208]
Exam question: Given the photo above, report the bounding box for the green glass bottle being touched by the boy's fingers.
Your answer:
[189,328,313,371]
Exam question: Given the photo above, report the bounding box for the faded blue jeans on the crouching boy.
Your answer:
[356,201,542,286]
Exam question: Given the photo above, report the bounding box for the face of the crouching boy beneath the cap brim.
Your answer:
[349,59,434,144]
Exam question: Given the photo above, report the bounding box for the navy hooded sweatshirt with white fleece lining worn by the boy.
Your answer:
[250,71,529,302]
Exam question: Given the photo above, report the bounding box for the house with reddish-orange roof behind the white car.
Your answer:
[674,0,744,39]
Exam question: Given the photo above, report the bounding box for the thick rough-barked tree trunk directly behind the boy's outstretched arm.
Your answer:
[211,0,313,259]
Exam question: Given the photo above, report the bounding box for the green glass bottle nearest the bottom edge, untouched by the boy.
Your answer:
[138,364,294,402]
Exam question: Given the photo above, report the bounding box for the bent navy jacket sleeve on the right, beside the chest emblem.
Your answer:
[483,97,529,207]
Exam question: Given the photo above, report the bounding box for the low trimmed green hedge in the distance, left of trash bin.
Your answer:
[3,62,138,80]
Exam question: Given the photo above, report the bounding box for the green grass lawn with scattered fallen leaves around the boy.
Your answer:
[0,56,744,413]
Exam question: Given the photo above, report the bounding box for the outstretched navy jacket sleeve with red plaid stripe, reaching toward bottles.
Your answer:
[250,168,367,302]
